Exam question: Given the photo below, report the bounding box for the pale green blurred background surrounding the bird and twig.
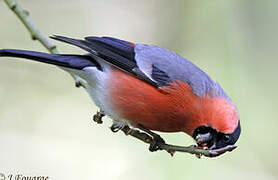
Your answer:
[0,0,278,180]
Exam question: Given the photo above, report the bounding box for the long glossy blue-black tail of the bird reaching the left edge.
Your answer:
[0,49,99,70]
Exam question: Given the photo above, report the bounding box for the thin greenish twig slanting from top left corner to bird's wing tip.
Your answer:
[4,0,58,54]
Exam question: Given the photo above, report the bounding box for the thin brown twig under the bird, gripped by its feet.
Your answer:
[121,126,237,158]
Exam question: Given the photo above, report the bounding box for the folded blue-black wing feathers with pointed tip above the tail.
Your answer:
[51,36,159,87]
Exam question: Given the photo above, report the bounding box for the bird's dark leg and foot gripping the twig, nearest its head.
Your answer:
[137,124,165,152]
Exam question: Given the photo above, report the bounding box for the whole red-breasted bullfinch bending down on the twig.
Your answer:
[0,36,241,150]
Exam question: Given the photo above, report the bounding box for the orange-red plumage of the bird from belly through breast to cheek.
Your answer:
[108,69,238,135]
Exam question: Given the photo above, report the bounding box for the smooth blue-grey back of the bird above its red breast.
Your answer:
[135,44,229,100]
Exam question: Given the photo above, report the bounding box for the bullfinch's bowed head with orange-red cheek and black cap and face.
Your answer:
[192,99,241,149]
